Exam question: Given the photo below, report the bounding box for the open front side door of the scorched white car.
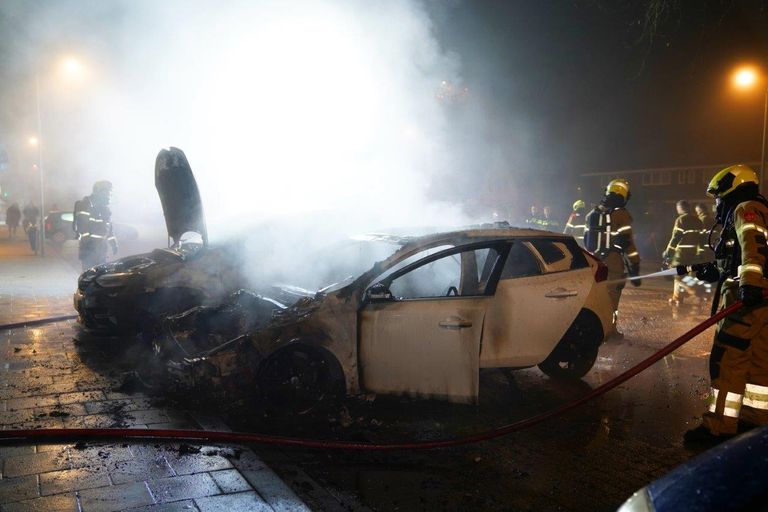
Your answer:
[359,245,504,402]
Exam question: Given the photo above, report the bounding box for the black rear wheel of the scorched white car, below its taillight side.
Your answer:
[538,310,603,380]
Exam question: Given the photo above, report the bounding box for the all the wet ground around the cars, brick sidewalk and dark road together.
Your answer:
[0,236,728,511]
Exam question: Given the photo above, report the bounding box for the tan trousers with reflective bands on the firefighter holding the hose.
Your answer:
[703,285,768,435]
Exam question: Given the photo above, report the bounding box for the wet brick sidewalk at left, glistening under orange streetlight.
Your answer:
[0,236,308,512]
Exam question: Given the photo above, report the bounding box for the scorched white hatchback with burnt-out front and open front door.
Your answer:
[155,226,614,411]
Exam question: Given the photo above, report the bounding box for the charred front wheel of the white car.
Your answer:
[258,347,343,415]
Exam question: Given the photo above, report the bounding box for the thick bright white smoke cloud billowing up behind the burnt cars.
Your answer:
[0,0,528,288]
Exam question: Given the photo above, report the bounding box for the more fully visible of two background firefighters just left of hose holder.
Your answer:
[662,200,702,306]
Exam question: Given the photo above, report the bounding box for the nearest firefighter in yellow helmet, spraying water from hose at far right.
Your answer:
[685,165,768,444]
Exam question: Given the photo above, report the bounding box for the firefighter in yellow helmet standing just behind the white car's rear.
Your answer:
[584,178,640,337]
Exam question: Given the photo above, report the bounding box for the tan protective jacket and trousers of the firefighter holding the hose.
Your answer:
[703,197,768,434]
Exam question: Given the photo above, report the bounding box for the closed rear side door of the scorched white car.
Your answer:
[480,238,593,367]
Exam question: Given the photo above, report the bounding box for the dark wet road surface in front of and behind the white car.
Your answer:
[252,280,712,511]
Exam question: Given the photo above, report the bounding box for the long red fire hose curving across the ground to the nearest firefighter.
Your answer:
[0,301,742,451]
